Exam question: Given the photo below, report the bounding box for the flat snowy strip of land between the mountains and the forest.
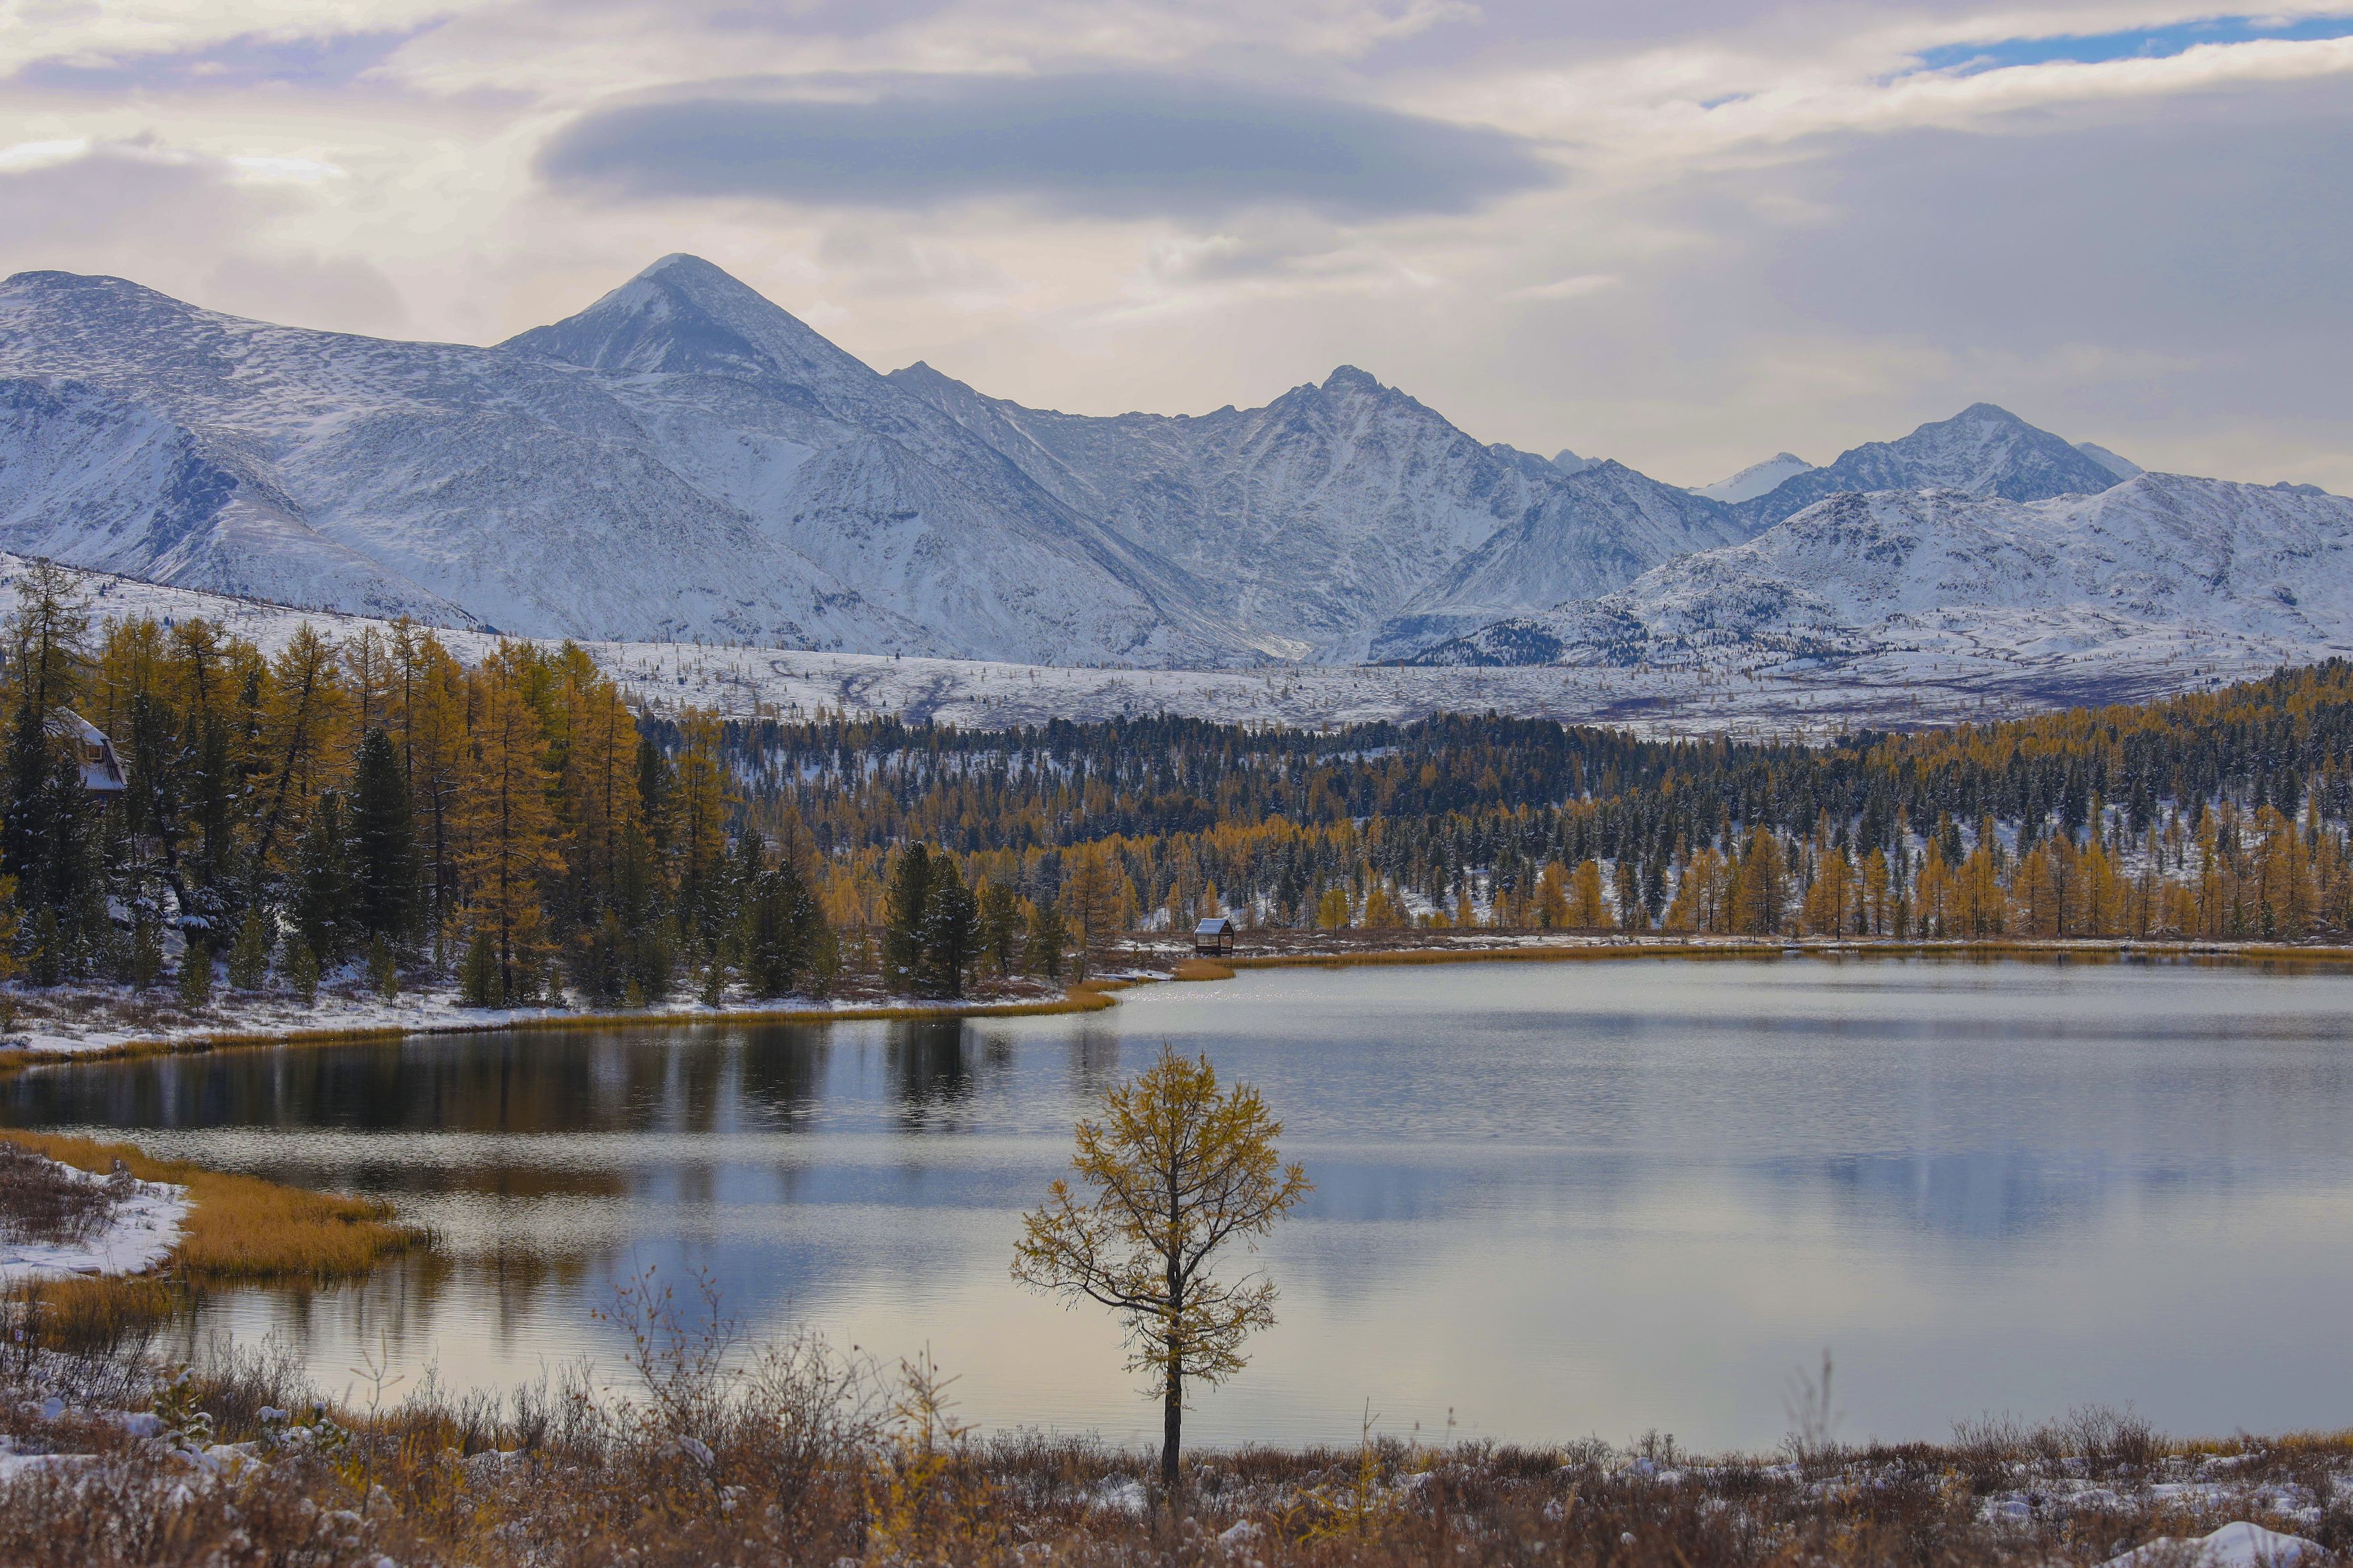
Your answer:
[0,554,2315,736]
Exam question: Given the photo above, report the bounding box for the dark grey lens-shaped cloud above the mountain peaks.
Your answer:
[539,75,1556,218]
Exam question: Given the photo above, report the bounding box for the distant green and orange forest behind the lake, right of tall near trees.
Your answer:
[696,661,2353,938]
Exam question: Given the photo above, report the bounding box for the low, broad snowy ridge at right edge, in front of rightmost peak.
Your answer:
[1424,475,2353,665]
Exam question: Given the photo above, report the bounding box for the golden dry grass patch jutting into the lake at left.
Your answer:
[0,1130,426,1284]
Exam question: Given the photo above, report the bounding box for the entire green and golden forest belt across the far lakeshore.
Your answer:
[0,564,2353,1006]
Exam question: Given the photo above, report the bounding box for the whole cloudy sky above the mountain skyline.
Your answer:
[0,0,2353,494]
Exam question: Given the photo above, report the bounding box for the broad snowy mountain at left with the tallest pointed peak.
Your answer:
[0,256,1252,661]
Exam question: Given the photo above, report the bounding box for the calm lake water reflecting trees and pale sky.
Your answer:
[0,959,2353,1446]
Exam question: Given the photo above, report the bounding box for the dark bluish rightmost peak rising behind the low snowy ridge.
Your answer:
[1739,402,2116,531]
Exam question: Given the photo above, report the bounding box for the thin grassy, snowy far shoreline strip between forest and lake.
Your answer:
[0,936,2353,1079]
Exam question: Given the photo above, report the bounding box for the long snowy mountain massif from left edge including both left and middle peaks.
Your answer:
[0,256,1798,665]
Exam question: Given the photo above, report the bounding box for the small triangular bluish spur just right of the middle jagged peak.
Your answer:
[1374,458,1751,658]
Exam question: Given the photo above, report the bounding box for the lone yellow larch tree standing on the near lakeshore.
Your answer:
[1014,1046,1313,1510]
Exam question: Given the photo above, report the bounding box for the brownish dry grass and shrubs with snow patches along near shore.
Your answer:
[0,1279,2353,1568]
